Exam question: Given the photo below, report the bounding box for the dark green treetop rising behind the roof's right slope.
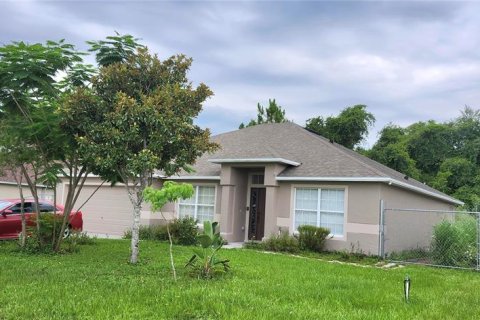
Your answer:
[306,104,375,149]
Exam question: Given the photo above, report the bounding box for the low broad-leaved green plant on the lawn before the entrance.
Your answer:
[185,221,230,278]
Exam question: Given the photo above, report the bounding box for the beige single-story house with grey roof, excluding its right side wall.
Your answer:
[56,122,461,254]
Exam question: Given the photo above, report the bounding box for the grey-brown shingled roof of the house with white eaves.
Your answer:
[173,122,461,204]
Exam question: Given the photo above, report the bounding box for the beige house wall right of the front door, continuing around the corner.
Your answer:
[276,182,453,255]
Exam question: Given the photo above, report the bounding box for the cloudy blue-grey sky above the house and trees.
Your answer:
[0,0,480,147]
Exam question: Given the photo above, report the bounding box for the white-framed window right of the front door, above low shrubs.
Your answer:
[294,188,345,236]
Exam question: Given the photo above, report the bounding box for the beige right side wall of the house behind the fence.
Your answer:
[381,185,454,254]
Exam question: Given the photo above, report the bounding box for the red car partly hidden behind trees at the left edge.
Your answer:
[0,199,83,239]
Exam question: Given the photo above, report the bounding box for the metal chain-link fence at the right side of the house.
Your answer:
[379,204,480,271]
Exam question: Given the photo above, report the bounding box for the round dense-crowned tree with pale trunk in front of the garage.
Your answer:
[67,42,217,263]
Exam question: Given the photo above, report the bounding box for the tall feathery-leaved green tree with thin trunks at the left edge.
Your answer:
[0,40,90,251]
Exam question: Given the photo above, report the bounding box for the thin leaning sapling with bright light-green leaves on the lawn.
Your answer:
[143,181,194,281]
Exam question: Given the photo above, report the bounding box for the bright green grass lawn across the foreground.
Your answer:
[0,240,480,319]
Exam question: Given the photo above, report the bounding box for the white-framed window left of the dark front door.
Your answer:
[178,186,215,224]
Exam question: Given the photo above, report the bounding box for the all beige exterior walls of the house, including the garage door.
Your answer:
[52,172,453,254]
